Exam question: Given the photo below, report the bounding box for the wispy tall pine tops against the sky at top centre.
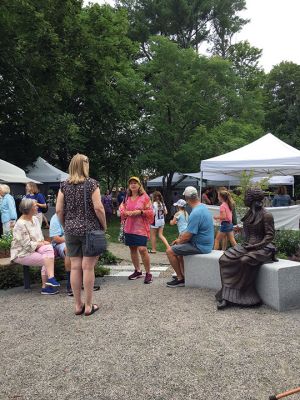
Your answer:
[117,0,248,59]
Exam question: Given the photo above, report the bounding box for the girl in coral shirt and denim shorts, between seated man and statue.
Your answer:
[214,190,236,250]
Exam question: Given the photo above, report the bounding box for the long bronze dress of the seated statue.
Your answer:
[216,209,275,306]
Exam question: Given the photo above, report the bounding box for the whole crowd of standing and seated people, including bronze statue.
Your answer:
[0,154,290,316]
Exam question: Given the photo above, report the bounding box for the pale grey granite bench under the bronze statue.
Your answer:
[184,250,300,311]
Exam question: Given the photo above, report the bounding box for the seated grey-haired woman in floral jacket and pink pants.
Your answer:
[11,198,60,295]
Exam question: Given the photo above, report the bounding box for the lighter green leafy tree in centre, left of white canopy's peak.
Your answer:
[140,37,241,208]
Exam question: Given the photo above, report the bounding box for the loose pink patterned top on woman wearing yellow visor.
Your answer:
[120,193,154,238]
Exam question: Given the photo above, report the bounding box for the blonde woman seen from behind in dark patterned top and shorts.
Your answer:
[56,154,106,316]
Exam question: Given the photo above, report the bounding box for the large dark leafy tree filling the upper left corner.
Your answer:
[0,0,143,186]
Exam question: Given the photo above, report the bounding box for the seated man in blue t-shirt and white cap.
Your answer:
[167,186,214,287]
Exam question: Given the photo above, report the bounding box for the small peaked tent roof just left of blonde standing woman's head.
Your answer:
[28,157,69,183]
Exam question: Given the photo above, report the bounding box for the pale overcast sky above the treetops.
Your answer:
[84,0,300,72]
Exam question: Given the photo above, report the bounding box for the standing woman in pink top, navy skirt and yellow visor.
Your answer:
[119,176,154,284]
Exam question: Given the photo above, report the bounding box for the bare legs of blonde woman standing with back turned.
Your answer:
[70,257,99,313]
